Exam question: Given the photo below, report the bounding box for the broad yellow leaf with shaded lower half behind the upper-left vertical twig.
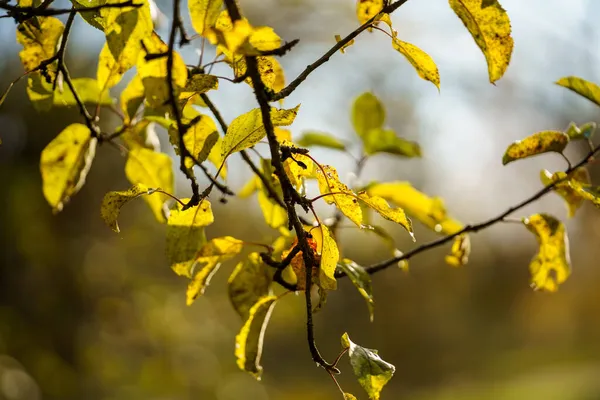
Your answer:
[137,32,187,109]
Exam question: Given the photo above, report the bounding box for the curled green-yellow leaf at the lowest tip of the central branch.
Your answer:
[342,333,396,400]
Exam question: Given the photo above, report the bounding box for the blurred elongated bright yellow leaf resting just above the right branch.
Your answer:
[367,182,463,235]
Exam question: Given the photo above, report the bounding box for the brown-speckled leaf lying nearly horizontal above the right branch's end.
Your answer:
[502,131,569,165]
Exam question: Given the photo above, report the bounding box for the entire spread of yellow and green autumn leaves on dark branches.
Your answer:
[0,0,600,399]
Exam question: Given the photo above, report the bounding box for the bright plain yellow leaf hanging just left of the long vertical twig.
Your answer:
[125,147,174,222]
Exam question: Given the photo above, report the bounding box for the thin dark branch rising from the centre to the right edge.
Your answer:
[335,146,600,278]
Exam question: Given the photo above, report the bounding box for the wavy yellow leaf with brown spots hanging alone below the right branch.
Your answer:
[523,214,571,292]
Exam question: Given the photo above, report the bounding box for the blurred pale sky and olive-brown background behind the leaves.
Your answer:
[0,0,600,400]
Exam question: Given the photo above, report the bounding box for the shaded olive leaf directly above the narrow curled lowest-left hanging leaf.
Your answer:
[228,253,272,321]
